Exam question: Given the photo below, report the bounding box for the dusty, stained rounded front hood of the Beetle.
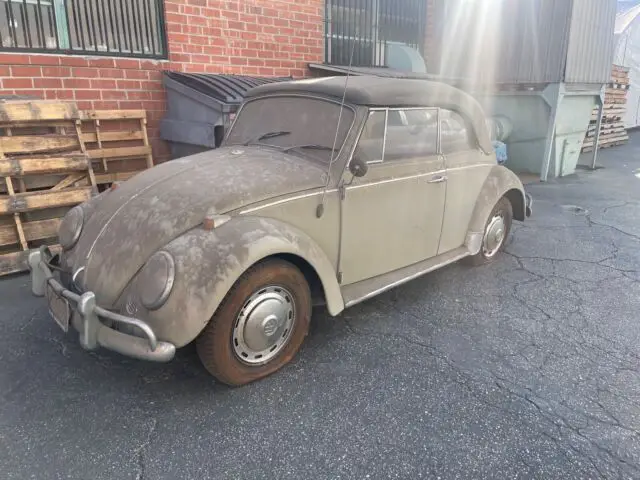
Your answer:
[69,147,326,304]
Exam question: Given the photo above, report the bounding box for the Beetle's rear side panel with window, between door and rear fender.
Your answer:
[438,110,496,254]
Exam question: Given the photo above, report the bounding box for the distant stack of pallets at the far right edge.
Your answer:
[582,65,629,152]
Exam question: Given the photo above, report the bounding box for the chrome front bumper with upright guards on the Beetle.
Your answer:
[28,247,176,362]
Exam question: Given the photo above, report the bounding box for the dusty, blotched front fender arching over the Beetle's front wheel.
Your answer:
[148,216,344,347]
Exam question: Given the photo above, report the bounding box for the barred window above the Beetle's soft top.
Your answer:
[325,0,427,67]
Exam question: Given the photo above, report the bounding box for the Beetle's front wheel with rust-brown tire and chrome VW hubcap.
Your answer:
[196,260,311,386]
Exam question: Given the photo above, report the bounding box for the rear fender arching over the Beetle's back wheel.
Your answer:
[465,165,526,255]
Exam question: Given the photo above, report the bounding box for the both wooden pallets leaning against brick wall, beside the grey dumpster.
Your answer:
[0,101,153,275]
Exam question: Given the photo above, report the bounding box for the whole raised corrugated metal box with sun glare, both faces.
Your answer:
[429,0,616,84]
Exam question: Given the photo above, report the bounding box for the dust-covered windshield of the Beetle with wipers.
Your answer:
[225,97,354,163]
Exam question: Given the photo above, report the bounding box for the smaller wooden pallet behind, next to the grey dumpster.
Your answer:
[82,110,153,185]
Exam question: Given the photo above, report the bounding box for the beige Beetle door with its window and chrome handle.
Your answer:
[340,109,446,285]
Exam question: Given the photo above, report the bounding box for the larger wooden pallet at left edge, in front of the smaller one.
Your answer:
[0,101,97,275]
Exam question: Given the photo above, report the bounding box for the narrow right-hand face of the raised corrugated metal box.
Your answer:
[565,0,617,83]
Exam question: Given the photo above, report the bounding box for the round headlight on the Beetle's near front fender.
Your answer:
[138,251,176,310]
